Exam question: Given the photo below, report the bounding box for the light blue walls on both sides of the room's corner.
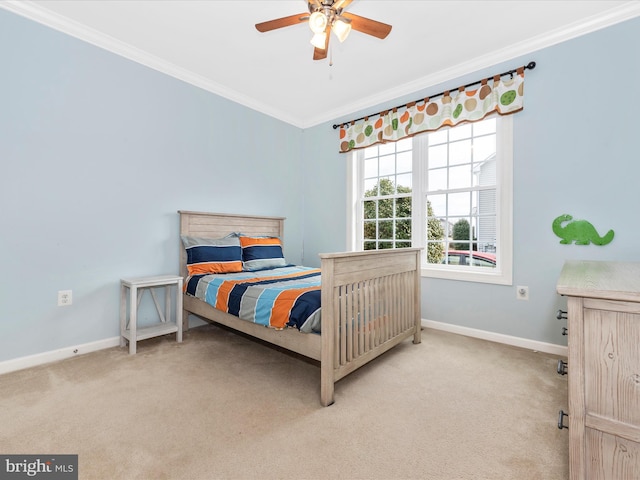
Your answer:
[0,10,640,361]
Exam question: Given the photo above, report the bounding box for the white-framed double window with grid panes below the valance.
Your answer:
[348,116,513,284]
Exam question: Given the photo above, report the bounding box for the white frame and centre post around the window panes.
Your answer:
[347,115,513,285]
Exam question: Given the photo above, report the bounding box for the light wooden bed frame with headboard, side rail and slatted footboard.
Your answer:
[178,210,421,406]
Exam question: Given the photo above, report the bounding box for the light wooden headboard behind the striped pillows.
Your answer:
[178,210,284,276]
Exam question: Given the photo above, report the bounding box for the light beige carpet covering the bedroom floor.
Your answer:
[0,325,568,480]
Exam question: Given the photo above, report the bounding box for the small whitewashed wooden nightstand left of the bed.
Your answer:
[120,275,182,354]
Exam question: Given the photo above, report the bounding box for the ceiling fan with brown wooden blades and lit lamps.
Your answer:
[256,0,391,60]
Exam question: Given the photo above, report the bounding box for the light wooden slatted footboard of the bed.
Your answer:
[320,248,420,404]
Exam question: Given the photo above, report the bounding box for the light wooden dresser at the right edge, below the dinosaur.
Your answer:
[557,261,640,480]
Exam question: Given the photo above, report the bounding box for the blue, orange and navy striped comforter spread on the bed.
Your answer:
[185,266,320,333]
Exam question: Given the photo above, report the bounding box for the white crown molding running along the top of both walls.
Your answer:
[0,0,640,129]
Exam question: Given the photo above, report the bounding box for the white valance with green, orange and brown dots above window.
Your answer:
[340,67,524,153]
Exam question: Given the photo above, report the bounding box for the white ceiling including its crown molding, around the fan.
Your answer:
[0,0,640,128]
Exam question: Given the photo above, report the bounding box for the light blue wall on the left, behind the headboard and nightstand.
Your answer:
[0,10,304,361]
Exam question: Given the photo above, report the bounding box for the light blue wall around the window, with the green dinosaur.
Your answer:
[304,18,640,345]
